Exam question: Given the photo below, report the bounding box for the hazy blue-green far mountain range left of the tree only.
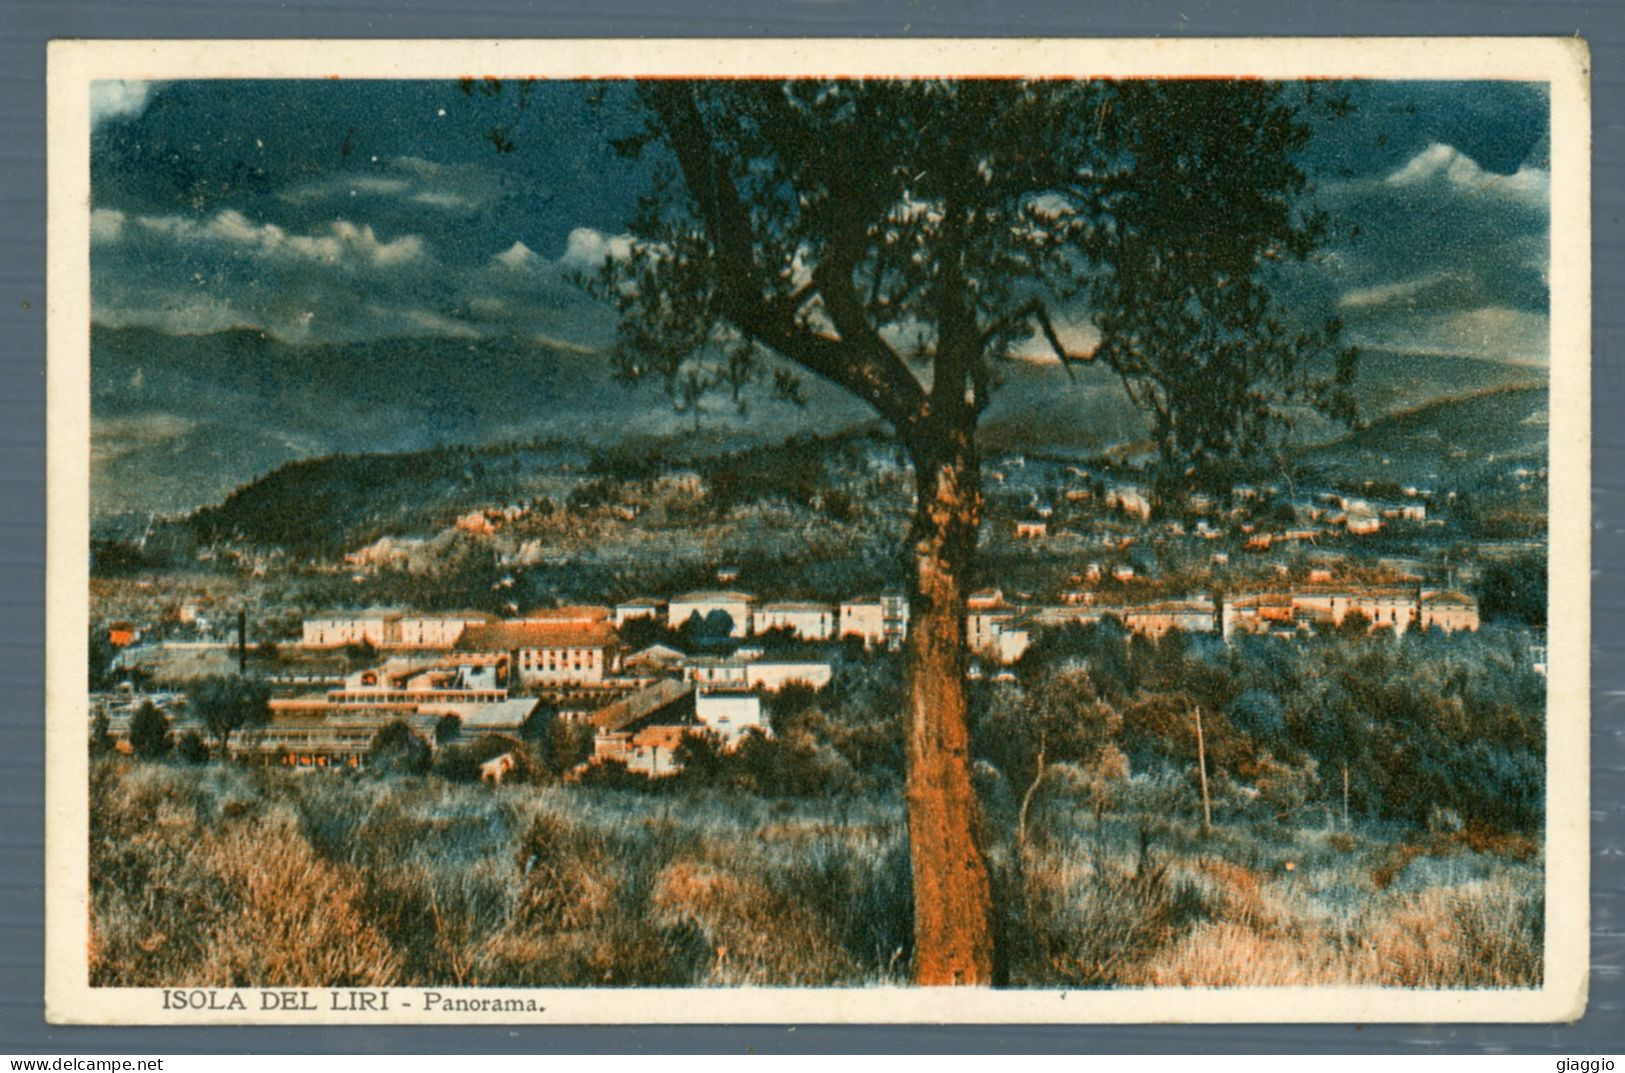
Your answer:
[91,327,866,515]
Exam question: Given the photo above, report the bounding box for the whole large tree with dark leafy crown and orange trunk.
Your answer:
[546,80,1354,984]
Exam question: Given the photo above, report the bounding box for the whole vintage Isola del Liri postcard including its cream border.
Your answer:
[46,39,1591,1024]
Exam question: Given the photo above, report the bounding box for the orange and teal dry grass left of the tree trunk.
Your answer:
[91,761,908,987]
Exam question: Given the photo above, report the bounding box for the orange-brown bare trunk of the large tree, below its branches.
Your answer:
[905,432,993,985]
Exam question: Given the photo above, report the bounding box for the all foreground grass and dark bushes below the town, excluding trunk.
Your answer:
[89,623,1545,987]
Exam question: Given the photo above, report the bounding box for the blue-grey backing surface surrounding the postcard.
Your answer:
[0,0,1625,1055]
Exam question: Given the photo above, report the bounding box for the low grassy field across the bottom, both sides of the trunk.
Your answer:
[91,759,1544,988]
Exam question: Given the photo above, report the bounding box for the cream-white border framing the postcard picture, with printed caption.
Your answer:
[46,37,1591,1024]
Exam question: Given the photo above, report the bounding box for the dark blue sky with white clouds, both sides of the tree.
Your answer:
[91,80,1550,364]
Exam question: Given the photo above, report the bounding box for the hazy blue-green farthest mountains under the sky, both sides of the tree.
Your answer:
[91,327,1542,523]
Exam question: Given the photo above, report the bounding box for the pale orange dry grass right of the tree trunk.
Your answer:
[1012,786,1544,988]
